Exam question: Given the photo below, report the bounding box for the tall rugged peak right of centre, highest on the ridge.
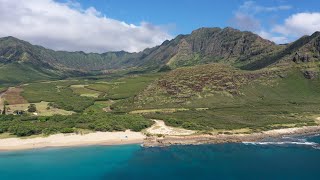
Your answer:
[135,28,278,68]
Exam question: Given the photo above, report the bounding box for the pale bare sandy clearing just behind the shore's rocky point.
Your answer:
[146,120,196,136]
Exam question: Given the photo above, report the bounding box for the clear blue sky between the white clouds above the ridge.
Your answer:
[74,0,320,38]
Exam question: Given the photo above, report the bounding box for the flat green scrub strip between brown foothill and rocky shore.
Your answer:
[144,105,320,130]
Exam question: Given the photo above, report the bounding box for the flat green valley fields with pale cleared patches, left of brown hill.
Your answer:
[18,74,159,112]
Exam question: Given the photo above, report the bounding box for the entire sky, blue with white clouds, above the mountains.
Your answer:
[0,0,320,53]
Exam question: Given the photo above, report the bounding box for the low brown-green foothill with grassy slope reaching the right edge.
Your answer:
[116,60,320,109]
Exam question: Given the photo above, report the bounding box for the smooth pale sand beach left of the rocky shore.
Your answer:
[0,130,145,151]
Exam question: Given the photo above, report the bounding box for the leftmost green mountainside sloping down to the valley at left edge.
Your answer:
[0,37,82,84]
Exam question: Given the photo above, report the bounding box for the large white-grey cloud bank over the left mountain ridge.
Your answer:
[0,0,172,52]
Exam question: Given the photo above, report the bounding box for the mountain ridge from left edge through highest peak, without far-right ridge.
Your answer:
[0,28,278,71]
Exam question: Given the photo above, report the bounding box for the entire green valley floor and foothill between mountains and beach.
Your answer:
[1,61,320,140]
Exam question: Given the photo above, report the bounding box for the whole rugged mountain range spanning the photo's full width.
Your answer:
[0,27,320,83]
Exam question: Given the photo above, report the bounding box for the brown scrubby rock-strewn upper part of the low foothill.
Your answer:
[157,65,275,95]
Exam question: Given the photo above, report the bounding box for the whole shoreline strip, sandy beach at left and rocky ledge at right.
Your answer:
[0,126,320,152]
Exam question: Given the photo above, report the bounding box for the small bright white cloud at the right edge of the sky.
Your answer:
[272,12,320,36]
